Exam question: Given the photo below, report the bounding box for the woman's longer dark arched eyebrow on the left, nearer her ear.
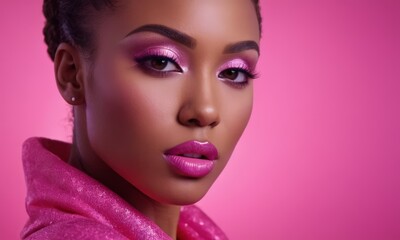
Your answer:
[126,24,196,48]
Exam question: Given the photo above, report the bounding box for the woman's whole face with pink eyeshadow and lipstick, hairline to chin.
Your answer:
[79,0,259,204]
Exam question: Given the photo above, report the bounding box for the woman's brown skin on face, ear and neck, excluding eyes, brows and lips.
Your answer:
[54,0,259,239]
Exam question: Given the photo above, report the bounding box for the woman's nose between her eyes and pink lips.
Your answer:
[178,79,220,128]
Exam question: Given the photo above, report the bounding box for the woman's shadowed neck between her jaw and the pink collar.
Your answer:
[69,137,180,239]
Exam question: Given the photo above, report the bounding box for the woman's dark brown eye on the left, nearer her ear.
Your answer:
[136,56,182,72]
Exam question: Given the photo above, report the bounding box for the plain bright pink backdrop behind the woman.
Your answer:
[0,0,400,240]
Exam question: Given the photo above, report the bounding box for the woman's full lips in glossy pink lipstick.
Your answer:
[164,141,218,178]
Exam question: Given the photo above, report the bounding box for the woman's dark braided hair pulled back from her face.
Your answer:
[43,0,261,60]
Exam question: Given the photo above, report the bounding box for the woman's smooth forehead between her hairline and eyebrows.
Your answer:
[96,0,259,43]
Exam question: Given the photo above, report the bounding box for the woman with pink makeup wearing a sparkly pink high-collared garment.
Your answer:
[22,0,261,239]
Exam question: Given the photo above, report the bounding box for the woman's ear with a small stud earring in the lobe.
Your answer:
[54,43,85,105]
